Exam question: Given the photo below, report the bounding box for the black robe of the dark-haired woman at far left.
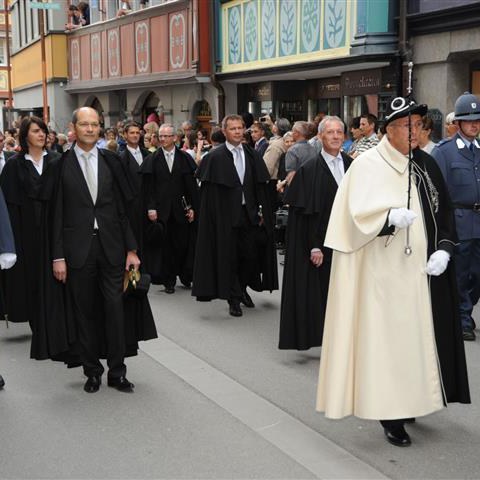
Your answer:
[0,152,75,360]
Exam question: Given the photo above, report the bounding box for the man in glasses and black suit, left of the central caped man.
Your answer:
[141,124,198,294]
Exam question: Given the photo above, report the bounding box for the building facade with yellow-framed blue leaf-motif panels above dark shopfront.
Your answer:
[216,0,402,125]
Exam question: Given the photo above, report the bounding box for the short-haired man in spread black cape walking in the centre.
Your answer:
[192,115,278,317]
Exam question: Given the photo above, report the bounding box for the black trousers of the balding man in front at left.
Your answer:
[67,235,126,378]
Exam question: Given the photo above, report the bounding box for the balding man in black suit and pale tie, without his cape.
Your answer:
[53,107,140,393]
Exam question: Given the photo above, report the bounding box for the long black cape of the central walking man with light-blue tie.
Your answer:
[192,144,278,301]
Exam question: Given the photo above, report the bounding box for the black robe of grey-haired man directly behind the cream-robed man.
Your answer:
[279,154,351,350]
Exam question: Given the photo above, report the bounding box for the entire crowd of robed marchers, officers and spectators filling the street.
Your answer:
[0,92,480,446]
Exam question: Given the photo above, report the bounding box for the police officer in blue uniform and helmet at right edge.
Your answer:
[432,92,480,340]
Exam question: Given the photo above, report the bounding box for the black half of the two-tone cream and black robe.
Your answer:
[412,148,470,403]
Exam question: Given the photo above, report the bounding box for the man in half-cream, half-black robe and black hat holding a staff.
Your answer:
[317,99,470,446]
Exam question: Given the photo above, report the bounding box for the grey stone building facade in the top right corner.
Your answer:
[406,0,480,140]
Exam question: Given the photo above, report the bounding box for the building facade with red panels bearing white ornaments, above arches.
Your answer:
[66,0,221,129]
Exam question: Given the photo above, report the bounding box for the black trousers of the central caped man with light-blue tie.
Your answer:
[229,207,258,302]
